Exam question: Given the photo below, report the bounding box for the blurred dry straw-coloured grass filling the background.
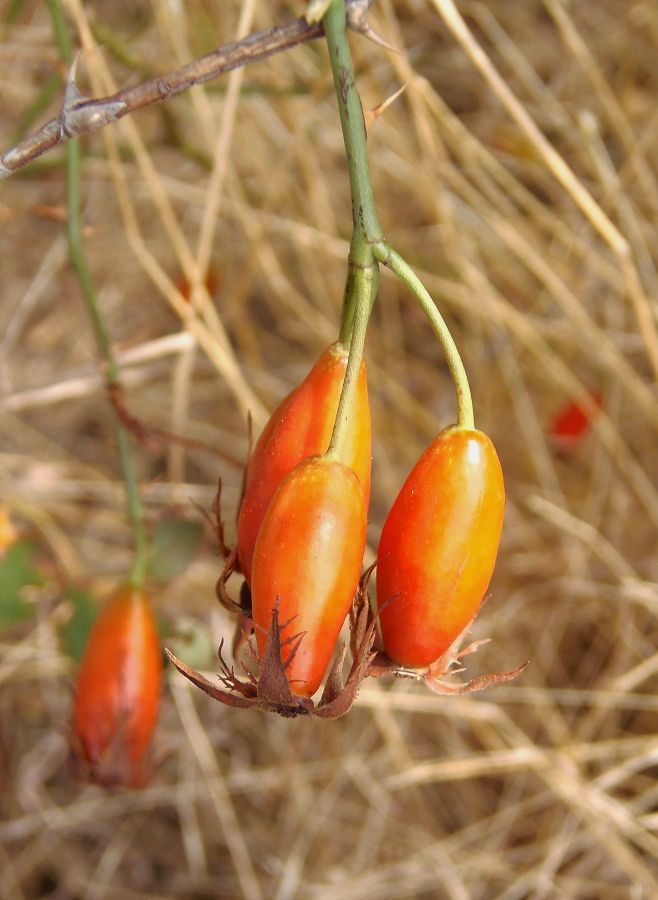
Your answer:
[0,0,658,900]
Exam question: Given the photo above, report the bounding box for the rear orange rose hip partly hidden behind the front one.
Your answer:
[237,343,372,585]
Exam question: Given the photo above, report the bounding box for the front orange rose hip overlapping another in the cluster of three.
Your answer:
[251,457,367,697]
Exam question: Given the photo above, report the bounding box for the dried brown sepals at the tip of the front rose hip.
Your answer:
[165,589,375,719]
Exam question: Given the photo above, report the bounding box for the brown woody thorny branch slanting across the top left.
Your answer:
[0,0,387,181]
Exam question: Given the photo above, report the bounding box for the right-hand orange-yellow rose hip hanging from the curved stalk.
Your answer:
[377,427,505,667]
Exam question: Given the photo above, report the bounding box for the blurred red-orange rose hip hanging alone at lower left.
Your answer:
[73,585,162,785]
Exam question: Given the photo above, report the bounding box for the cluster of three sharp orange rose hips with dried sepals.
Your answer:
[167,343,505,715]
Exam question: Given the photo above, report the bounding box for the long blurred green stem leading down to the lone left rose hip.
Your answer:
[48,0,147,587]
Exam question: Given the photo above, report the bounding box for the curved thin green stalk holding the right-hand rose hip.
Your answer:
[374,242,475,428]
